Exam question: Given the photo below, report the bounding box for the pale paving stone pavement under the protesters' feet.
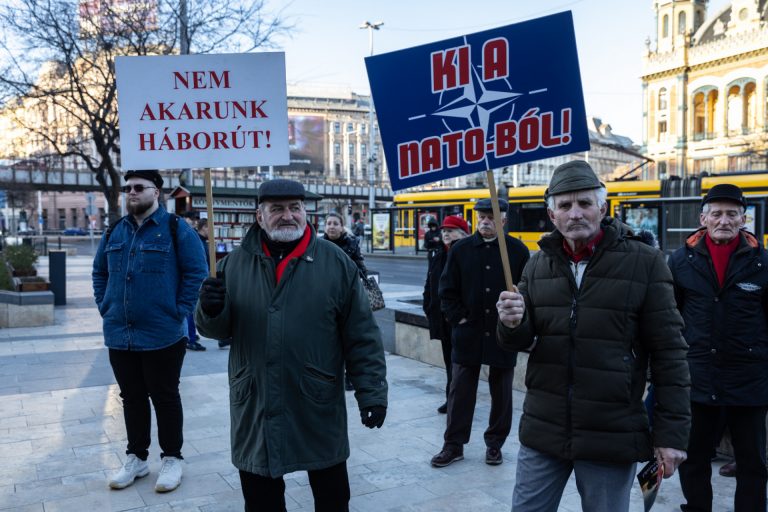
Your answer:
[0,256,735,512]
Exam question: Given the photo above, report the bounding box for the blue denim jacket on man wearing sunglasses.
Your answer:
[92,206,207,350]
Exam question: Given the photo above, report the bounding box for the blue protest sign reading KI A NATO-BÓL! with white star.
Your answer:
[365,12,589,190]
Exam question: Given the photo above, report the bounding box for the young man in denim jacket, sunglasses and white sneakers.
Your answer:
[93,170,207,492]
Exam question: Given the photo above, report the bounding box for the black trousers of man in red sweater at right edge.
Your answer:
[679,403,768,512]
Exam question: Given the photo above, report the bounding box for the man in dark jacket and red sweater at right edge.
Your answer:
[669,184,768,512]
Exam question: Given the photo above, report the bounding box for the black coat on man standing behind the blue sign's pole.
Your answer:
[438,232,530,368]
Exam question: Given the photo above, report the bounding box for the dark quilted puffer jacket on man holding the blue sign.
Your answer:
[498,217,690,462]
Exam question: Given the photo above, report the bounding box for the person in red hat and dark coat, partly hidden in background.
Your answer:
[422,215,469,414]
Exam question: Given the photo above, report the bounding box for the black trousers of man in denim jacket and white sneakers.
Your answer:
[109,338,187,460]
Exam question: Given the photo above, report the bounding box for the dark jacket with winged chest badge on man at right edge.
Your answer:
[669,228,768,406]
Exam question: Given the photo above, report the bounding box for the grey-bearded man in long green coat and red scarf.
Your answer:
[196,179,387,512]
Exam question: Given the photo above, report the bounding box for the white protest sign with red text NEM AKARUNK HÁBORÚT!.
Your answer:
[115,52,289,169]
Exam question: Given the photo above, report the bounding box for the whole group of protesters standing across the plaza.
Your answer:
[88,165,768,512]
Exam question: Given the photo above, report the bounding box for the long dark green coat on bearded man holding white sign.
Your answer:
[195,224,387,478]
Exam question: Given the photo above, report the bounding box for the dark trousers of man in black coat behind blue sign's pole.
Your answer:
[444,363,515,449]
